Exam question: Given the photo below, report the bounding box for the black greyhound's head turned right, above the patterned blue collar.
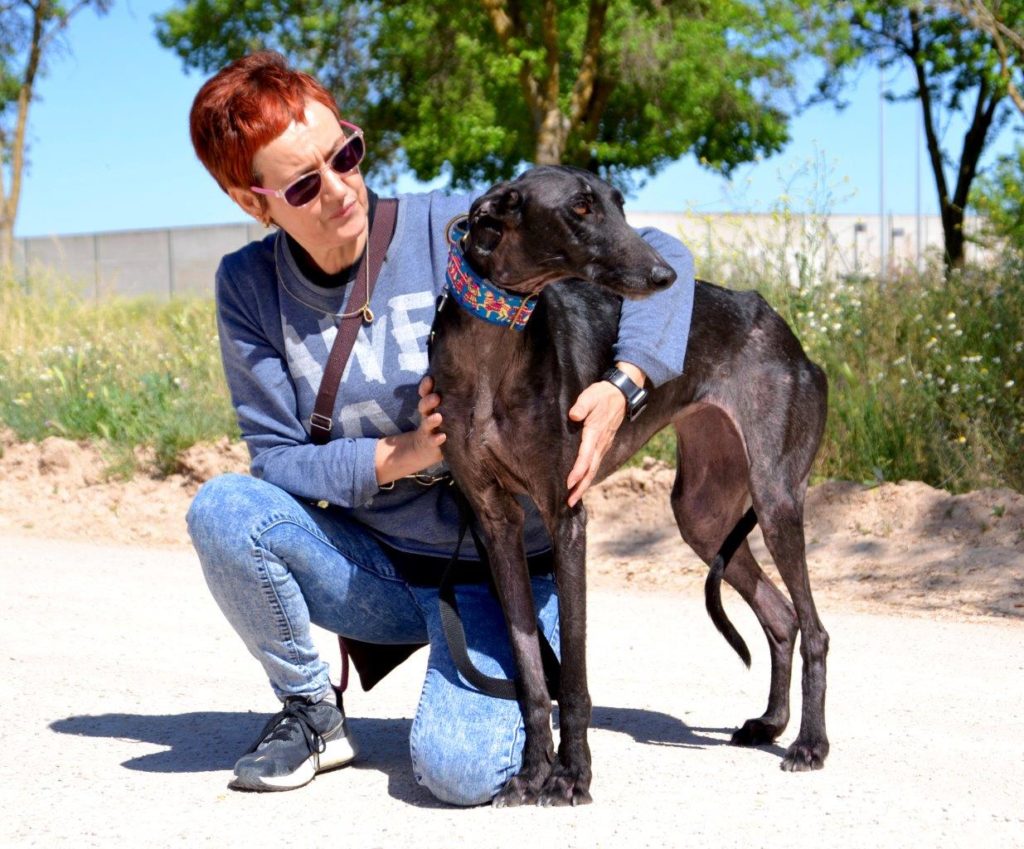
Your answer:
[463,166,676,298]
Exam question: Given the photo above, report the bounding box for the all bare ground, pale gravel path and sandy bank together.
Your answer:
[0,431,1024,849]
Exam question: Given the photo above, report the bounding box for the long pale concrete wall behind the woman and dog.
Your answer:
[14,213,966,299]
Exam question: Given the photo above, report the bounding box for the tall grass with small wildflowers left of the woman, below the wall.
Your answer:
[0,280,238,472]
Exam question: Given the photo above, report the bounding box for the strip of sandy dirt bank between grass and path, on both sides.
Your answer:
[0,430,1024,621]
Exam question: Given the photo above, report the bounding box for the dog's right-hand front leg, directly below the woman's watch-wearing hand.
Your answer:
[539,503,591,805]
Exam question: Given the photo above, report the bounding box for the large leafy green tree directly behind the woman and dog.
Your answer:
[158,0,815,188]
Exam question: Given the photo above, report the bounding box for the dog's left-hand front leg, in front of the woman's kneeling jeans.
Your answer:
[467,487,555,807]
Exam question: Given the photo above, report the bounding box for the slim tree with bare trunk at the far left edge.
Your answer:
[0,0,112,269]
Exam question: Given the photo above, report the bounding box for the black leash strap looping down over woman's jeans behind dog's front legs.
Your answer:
[437,484,561,701]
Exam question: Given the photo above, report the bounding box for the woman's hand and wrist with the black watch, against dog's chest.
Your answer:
[567,363,646,507]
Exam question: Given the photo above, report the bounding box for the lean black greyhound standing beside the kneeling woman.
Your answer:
[430,161,828,806]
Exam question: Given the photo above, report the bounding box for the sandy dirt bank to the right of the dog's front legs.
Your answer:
[587,463,1024,618]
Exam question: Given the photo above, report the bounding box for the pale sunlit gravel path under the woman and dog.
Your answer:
[0,536,1024,849]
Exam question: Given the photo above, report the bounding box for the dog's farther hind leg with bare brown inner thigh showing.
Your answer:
[672,406,797,746]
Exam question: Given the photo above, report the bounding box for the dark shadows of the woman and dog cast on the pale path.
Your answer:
[50,707,783,807]
